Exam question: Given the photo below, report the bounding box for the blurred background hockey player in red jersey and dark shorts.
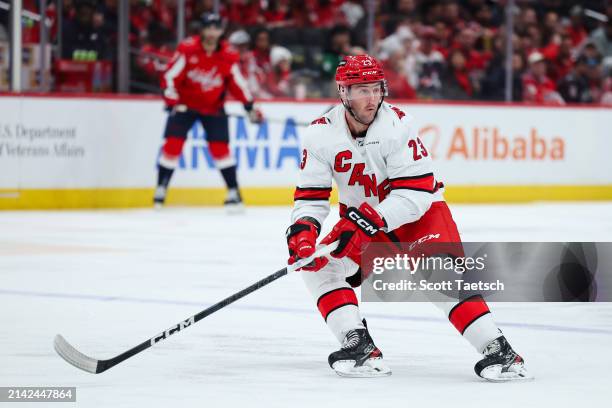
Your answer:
[153,13,263,208]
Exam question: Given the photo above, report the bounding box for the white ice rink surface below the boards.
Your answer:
[0,203,612,408]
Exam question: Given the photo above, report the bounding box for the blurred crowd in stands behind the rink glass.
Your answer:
[0,0,612,104]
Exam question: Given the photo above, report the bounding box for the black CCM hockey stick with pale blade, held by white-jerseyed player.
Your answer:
[53,241,338,374]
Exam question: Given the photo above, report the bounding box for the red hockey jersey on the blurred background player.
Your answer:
[161,35,253,114]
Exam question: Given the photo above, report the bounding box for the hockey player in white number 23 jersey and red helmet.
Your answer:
[286,55,529,381]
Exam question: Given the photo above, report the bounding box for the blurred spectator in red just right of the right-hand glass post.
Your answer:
[523,51,563,103]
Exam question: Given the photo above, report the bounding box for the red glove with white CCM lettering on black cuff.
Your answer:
[321,203,385,265]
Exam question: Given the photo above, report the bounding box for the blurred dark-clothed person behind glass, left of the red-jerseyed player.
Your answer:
[62,0,108,60]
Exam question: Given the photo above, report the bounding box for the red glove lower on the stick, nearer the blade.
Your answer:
[285,217,329,272]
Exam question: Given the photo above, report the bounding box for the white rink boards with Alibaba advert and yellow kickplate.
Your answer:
[0,96,612,209]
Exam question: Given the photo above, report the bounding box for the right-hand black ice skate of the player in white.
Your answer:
[474,336,533,382]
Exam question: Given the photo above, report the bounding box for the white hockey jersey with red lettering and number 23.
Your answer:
[291,102,444,231]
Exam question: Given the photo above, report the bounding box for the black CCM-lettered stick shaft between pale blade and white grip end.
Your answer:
[96,268,287,373]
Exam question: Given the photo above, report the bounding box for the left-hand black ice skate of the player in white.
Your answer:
[328,329,391,377]
